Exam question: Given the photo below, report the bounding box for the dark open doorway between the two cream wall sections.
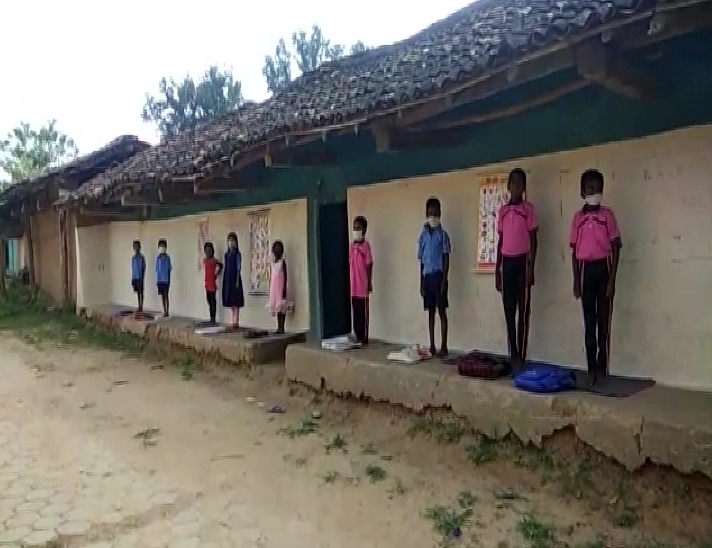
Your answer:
[319,201,351,339]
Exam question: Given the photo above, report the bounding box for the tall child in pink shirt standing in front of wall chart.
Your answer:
[495,168,539,368]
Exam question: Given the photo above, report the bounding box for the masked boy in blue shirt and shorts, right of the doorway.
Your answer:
[418,198,451,357]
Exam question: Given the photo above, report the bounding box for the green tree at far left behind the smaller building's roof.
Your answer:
[0,120,79,184]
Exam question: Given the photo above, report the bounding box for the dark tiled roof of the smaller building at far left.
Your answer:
[0,135,151,207]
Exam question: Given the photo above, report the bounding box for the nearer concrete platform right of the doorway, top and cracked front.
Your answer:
[286,344,712,479]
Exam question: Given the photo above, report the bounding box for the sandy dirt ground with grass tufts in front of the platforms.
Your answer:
[0,334,712,548]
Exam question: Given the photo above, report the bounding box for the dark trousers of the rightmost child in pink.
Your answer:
[580,259,613,375]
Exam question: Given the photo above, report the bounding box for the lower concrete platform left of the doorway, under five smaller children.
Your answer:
[86,304,305,366]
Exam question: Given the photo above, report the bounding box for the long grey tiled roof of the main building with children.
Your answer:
[72,0,663,203]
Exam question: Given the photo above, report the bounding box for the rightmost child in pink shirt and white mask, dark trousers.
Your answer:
[569,169,623,384]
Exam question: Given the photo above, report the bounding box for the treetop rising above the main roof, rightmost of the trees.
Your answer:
[262,25,368,94]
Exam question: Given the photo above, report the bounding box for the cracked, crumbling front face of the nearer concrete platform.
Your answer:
[285,344,712,479]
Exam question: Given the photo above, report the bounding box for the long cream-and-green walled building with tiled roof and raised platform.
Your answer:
[9,0,712,477]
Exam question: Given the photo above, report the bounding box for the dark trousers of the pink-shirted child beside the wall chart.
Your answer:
[502,255,531,360]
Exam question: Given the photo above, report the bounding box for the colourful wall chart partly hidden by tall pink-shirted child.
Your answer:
[475,173,509,272]
